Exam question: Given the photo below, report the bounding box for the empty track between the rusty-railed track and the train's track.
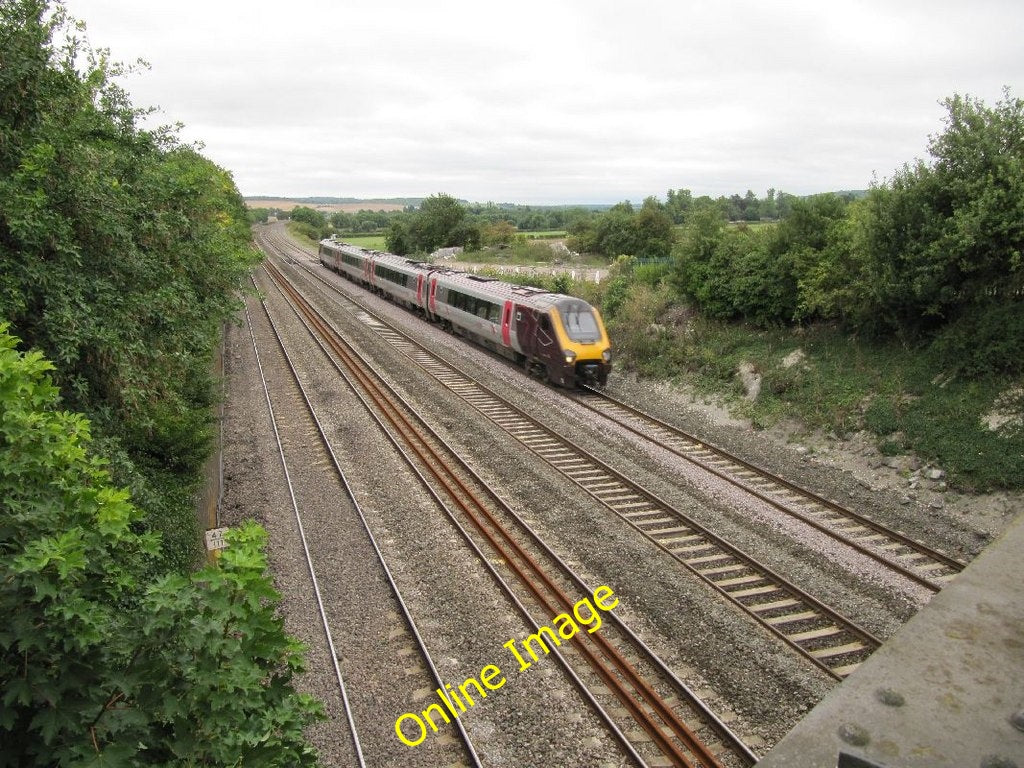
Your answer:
[258,237,881,680]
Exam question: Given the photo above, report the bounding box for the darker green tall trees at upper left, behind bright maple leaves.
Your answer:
[0,0,256,567]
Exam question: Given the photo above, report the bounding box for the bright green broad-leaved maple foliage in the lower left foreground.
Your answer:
[0,326,319,766]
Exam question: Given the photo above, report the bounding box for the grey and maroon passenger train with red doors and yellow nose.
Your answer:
[319,238,611,388]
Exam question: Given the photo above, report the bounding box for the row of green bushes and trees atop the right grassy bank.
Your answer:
[671,91,1024,373]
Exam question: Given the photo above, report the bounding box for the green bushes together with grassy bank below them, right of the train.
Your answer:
[572,91,1024,489]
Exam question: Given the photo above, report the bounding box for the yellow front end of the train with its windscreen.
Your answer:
[551,296,611,386]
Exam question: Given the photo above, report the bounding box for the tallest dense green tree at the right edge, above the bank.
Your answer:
[803,91,1024,354]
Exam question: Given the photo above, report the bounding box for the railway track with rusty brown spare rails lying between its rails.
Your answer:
[265,263,757,766]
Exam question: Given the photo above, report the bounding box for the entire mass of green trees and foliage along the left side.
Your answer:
[0,0,315,766]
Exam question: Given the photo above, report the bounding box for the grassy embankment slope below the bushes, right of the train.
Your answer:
[609,285,1024,490]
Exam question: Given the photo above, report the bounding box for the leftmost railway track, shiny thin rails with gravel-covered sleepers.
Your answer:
[246,281,482,768]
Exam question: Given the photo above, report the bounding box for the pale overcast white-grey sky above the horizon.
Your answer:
[67,0,1024,204]
